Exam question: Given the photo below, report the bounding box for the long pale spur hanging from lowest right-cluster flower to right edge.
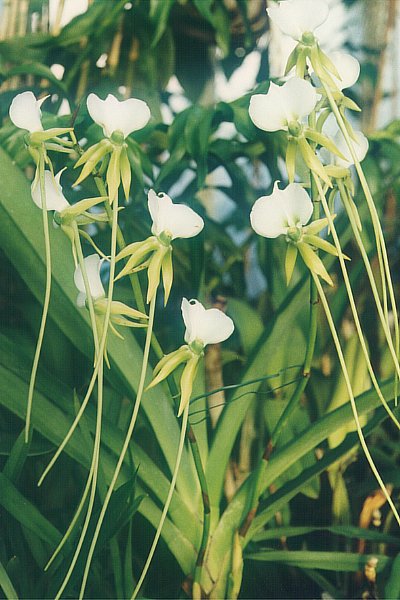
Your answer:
[312,273,400,525]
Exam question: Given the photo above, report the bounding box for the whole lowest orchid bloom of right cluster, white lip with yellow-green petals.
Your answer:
[250,182,347,285]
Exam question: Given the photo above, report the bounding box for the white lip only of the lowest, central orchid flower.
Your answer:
[181,298,235,354]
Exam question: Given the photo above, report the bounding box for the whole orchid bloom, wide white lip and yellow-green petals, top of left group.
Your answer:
[74,94,151,204]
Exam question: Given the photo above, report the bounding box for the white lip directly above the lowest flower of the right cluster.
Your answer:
[249,77,317,131]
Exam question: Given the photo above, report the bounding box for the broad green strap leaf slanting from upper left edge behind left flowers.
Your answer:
[0,149,198,504]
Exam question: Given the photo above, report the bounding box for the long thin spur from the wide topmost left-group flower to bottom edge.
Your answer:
[56,199,118,600]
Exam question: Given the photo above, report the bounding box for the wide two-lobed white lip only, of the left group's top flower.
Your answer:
[87,94,151,138]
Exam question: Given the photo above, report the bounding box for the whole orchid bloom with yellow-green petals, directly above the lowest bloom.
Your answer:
[116,190,204,305]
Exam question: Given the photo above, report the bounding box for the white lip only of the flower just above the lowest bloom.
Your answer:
[148,190,204,243]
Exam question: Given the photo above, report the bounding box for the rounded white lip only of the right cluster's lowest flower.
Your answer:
[250,181,313,241]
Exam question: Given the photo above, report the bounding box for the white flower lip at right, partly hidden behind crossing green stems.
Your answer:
[320,114,369,169]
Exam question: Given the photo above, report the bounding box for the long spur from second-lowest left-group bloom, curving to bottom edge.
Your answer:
[80,294,156,597]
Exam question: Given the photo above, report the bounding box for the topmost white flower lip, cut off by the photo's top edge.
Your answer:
[267,0,329,41]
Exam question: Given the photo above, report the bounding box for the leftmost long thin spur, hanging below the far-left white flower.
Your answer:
[25,146,51,444]
